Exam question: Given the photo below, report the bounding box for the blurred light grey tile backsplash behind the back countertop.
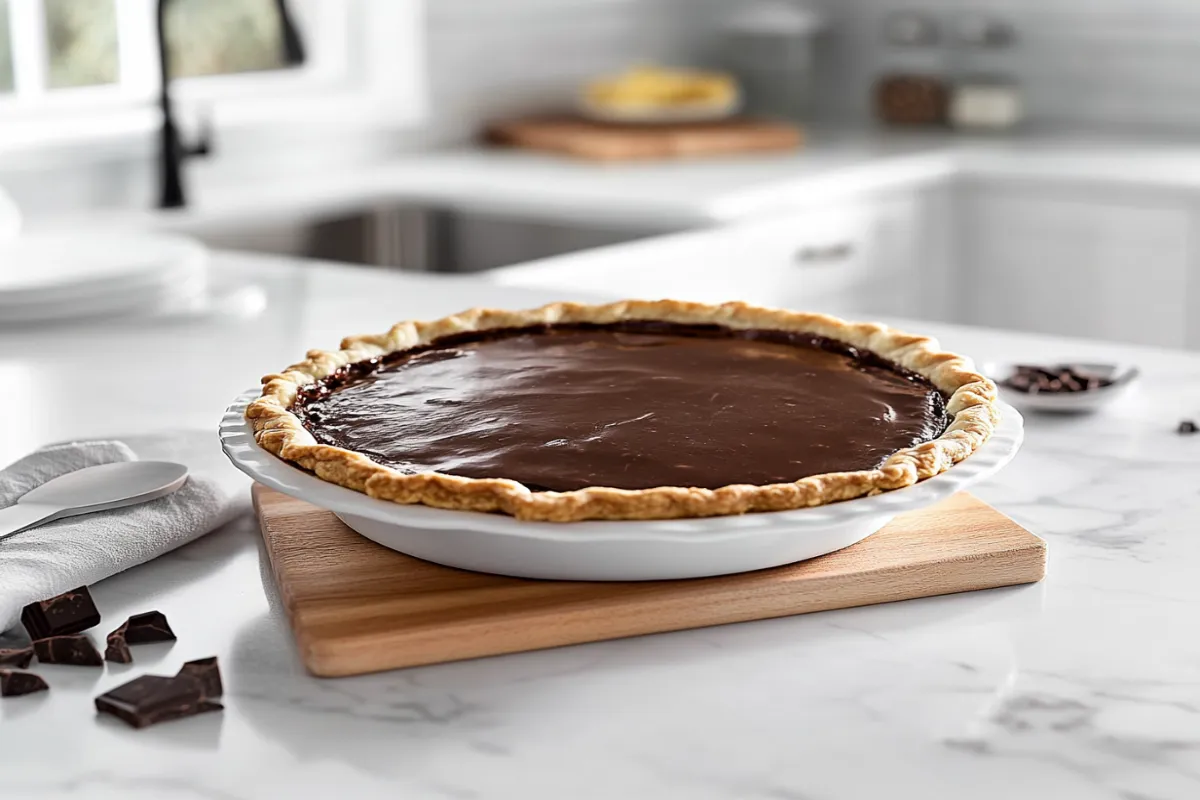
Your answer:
[427,0,1200,138]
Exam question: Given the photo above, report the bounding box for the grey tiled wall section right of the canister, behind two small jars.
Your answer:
[815,0,1200,133]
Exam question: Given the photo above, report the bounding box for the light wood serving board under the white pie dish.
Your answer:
[254,486,1045,676]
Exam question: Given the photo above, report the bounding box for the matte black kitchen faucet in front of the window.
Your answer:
[155,0,305,209]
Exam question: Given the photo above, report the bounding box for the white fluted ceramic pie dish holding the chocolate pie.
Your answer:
[220,389,1024,581]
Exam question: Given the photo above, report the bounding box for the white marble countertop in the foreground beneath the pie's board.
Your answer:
[0,255,1200,800]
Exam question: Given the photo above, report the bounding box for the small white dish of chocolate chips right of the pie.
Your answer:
[984,361,1138,413]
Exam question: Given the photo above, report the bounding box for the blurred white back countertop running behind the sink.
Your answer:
[25,128,1200,233]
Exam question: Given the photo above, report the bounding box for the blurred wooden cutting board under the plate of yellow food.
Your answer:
[485,116,803,161]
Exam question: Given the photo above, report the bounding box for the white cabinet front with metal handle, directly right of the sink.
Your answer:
[485,192,925,317]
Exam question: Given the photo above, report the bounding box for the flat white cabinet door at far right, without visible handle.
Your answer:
[960,186,1190,347]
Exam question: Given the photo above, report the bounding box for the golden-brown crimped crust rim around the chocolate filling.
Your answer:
[246,300,1000,522]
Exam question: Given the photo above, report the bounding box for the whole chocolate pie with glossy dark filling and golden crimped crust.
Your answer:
[246,301,998,522]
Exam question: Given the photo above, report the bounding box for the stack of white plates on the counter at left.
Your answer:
[0,233,208,325]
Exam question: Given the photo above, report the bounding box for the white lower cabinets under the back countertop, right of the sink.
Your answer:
[488,178,1200,349]
